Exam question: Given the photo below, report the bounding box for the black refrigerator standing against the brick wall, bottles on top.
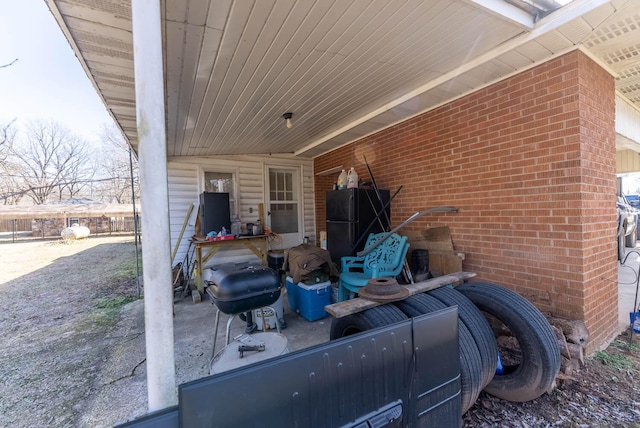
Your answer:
[326,189,391,267]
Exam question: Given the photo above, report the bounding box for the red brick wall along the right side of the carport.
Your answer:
[314,51,617,347]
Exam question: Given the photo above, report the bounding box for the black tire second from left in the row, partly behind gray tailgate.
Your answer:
[394,294,484,414]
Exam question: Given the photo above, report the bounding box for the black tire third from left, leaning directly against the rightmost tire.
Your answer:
[427,287,498,388]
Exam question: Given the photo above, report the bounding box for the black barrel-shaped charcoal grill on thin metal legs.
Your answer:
[207,266,281,359]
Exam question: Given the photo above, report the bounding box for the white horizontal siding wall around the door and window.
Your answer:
[168,156,315,265]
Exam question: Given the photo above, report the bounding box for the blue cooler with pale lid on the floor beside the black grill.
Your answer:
[287,276,331,321]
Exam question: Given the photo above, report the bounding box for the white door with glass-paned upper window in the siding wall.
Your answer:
[266,167,303,249]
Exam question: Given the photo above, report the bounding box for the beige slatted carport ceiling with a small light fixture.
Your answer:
[46,0,640,156]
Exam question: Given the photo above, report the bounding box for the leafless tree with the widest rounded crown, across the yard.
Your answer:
[11,121,91,205]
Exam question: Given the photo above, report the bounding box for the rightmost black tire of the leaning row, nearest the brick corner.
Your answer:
[456,283,560,402]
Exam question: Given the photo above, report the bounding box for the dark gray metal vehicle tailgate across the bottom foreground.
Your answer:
[179,308,461,428]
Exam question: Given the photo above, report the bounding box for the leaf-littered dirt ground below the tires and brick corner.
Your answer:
[463,334,640,428]
